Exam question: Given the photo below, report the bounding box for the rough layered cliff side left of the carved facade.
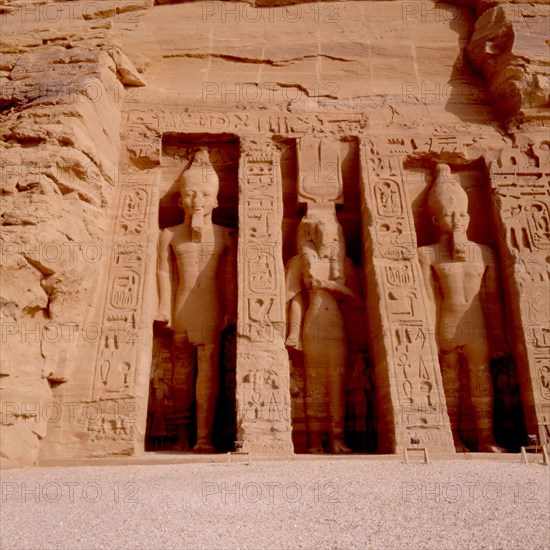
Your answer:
[0,3,149,465]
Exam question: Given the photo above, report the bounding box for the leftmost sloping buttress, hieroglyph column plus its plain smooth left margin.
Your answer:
[42,164,158,458]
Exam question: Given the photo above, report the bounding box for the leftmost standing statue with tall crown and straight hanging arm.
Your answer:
[157,148,233,453]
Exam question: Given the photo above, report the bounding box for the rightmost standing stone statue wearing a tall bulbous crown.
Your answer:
[419,164,505,452]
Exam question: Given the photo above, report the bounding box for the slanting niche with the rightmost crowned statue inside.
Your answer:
[407,163,526,452]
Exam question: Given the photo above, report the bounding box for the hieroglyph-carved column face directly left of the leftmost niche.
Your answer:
[88,172,159,454]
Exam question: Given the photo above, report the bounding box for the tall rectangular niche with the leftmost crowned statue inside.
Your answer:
[146,134,239,453]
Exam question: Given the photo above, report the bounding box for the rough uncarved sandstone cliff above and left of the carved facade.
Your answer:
[0,0,550,465]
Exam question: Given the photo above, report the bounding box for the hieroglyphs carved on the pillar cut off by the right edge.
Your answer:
[490,148,550,443]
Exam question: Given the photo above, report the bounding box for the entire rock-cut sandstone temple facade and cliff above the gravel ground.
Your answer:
[0,0,550,466]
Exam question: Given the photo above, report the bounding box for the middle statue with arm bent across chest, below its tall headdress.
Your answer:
[286,204,356,453]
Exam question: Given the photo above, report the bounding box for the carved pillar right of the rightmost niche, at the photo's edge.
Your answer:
[490,148,550,444]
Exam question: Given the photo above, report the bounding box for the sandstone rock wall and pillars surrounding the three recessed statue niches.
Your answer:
[0,0,550,465]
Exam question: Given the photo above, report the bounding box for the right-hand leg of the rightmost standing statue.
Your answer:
[464,339,504,453]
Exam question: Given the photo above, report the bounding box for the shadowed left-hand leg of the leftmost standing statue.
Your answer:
[172,335,195,451]
